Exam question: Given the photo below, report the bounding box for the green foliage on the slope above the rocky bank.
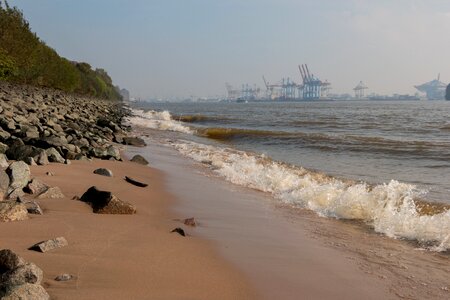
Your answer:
[0,0,121,100]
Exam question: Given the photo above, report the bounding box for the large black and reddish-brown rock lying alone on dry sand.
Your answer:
[80,186,136,214]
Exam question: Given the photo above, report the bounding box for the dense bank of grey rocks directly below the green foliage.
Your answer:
[0,81,136,165]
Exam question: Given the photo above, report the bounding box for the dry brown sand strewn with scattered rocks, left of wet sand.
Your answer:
[0,160,257,299]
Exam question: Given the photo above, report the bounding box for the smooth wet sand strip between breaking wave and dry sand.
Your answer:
[127,137,450,299]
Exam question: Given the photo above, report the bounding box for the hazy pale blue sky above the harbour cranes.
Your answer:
[9,0,450,99]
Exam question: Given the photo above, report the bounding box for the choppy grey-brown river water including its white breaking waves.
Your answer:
[129,101,450,251]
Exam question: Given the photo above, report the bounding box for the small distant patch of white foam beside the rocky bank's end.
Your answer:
[127,109,193,134]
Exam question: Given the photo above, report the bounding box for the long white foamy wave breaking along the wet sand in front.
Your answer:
[173,141,450,251]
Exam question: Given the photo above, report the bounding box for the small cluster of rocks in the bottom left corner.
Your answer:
[0,249,50,300]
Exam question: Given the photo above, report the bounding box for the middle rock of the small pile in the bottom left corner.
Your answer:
[1,263,44,286]
